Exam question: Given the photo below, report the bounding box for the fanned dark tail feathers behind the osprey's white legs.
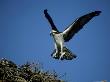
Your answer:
[51,47,77,60]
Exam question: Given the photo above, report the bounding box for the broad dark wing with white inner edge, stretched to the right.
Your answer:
[63,11,101,42]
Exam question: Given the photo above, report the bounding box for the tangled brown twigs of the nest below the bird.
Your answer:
[0,59,64,82]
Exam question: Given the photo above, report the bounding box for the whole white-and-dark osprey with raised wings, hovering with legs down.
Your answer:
[44,9,101,60]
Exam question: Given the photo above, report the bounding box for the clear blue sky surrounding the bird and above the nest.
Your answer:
[0,0,110,82]
